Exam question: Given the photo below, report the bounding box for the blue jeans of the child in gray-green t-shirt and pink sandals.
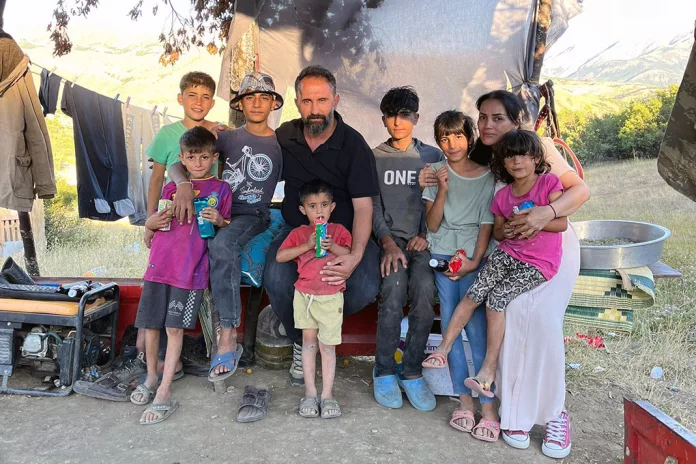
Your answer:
[432,255,495,403]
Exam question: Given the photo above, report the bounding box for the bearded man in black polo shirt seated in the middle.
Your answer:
[264,66,380,386]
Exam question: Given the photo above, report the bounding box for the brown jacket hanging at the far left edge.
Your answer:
[0,30,56,212]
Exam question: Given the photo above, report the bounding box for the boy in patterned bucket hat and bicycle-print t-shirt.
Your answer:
[208,73,283,381]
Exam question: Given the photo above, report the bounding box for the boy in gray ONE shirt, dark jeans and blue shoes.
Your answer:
[373,87,444,411]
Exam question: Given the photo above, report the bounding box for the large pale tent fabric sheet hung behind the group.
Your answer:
[218,0,582,146]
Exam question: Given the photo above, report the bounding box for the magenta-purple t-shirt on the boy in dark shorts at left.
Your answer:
[143,177,232,290]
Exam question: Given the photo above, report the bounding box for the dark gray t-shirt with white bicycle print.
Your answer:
[217,127,283,215]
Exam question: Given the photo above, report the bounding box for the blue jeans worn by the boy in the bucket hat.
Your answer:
[208,209,275,329]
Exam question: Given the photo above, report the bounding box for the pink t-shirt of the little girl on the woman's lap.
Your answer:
[491,174,563,280]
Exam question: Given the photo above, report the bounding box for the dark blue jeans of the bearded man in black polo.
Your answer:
[263,225,380,345]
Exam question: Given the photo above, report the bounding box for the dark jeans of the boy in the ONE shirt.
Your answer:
[375,237,435,377]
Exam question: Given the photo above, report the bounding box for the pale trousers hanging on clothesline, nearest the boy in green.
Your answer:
[123,105,160,226]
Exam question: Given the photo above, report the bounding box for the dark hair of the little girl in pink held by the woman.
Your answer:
[491,129,551,184]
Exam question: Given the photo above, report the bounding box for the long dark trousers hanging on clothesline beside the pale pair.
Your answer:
[61,82,135,221]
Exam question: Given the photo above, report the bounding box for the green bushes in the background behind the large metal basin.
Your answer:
[558,86,677,163]
